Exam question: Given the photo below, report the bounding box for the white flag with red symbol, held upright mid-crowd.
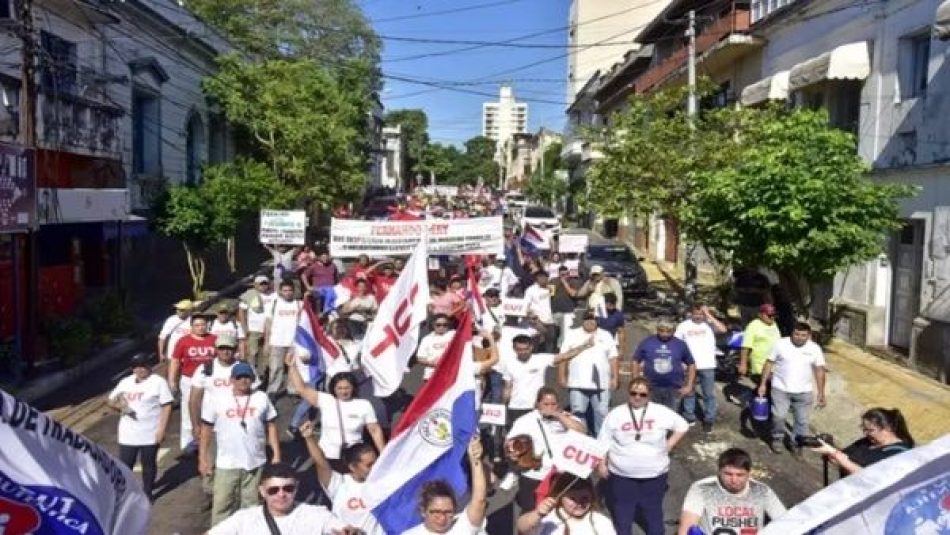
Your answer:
[362,240,429,397]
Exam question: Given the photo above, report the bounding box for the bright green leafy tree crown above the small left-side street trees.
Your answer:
[204,55,369,208]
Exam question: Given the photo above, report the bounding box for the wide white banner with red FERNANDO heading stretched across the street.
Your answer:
[330,217,505,258]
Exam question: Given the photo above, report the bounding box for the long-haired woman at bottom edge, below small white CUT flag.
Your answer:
[518,472,612,535]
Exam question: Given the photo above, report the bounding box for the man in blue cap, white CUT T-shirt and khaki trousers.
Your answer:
[198,362,280,526]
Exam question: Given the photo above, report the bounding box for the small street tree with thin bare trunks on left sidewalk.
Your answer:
[156,159,294,299]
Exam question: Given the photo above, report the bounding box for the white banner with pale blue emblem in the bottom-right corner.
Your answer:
[761,435,950,535]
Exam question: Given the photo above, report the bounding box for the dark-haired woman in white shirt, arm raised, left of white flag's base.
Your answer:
[287,362,386,472]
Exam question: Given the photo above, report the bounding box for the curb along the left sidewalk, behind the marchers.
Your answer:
[16,266,264,403]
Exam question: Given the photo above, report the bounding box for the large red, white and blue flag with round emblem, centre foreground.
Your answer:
[363,311,478,535]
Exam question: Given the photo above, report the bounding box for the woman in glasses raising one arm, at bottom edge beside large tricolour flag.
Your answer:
[403,435,488,535]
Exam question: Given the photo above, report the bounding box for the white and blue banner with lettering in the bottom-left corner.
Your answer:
[0,390,151,535]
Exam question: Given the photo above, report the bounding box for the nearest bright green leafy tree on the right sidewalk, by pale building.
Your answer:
[680,107,913,314]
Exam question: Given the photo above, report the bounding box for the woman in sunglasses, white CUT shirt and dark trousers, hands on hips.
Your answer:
[598,377,689,535]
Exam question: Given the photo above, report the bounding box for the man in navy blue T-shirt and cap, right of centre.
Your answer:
[632,319,696,412]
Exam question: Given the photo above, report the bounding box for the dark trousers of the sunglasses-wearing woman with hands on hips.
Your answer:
[607,474,668,535]
